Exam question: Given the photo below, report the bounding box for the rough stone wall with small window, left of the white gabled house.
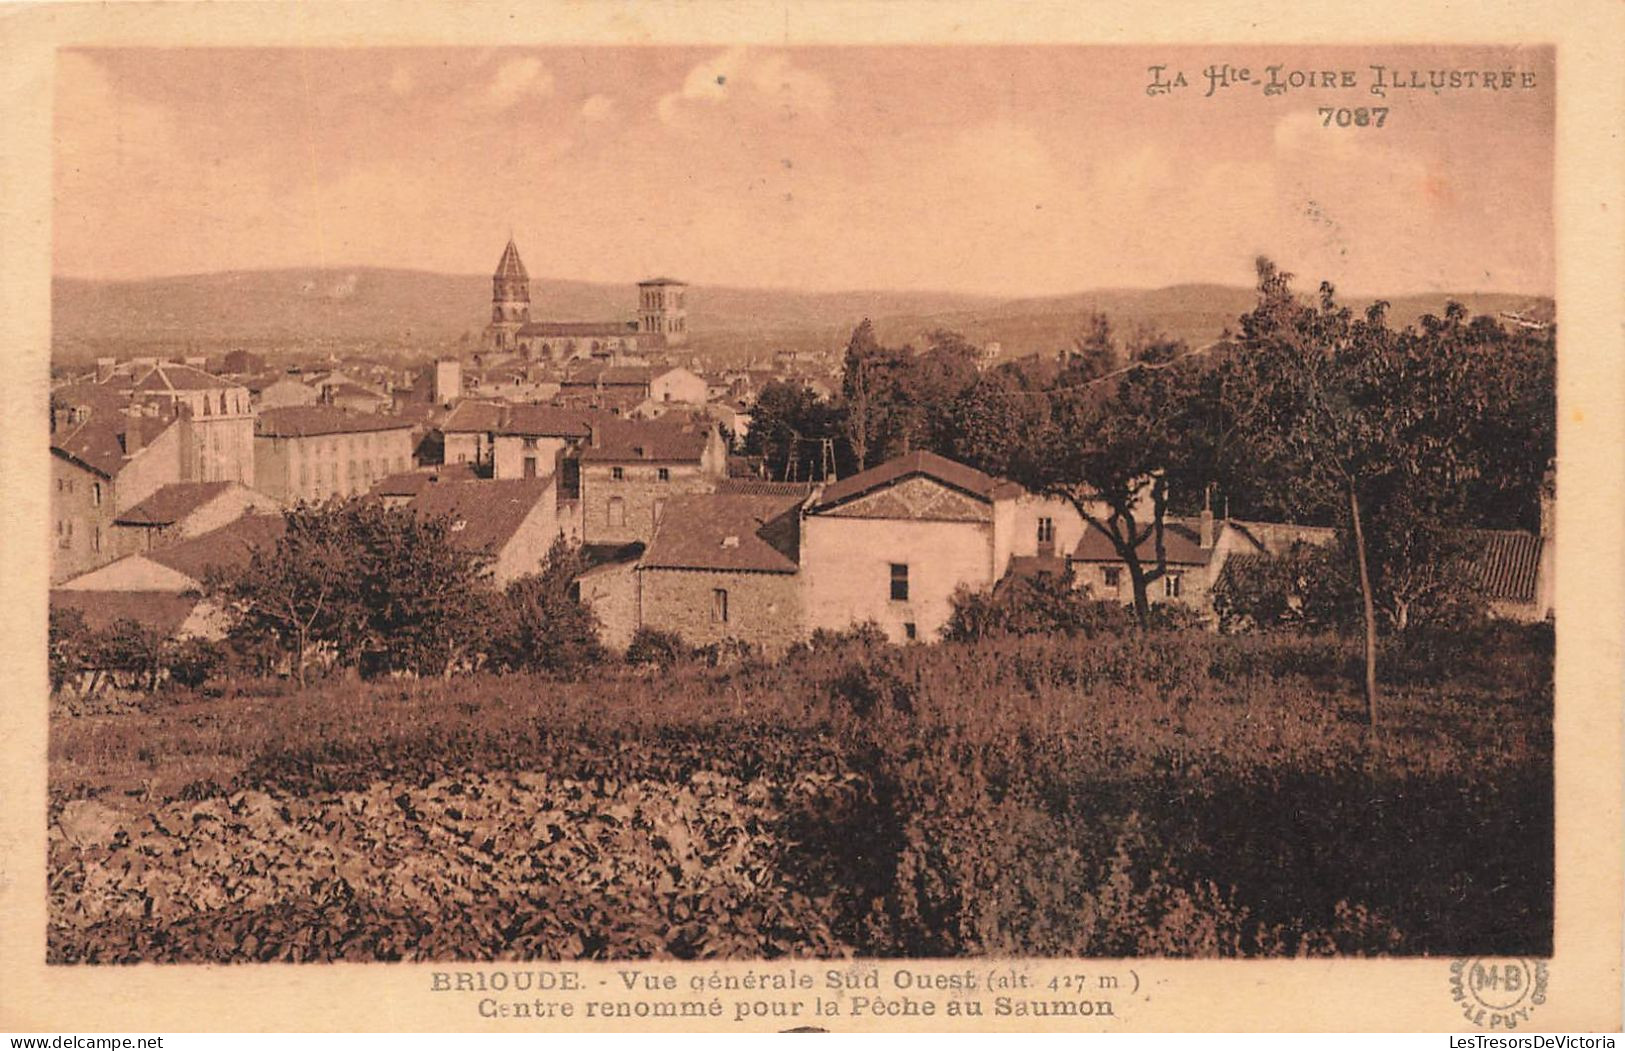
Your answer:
[639,567,806,656]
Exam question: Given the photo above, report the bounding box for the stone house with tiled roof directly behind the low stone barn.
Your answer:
[579,419,728,544]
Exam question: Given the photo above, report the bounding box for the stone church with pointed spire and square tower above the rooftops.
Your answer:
[484,237,689,364]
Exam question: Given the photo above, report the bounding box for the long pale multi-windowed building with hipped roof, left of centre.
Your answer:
[254,404,414,504]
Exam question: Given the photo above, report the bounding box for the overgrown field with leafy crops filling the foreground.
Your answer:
[49,625,1554,962]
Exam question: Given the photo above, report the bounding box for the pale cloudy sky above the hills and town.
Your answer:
[54,45,1555,297]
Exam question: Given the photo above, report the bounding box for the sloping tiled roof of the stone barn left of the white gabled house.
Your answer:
[639,494,801,573]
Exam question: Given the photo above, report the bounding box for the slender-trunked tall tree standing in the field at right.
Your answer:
[1242,260,1493,728]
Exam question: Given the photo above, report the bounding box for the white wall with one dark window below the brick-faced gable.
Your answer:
[801,513,993,642]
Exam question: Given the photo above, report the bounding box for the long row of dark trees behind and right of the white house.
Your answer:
[751,260,1557,718]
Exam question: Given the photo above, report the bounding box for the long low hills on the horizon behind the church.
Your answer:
[52,268,1552,368]
